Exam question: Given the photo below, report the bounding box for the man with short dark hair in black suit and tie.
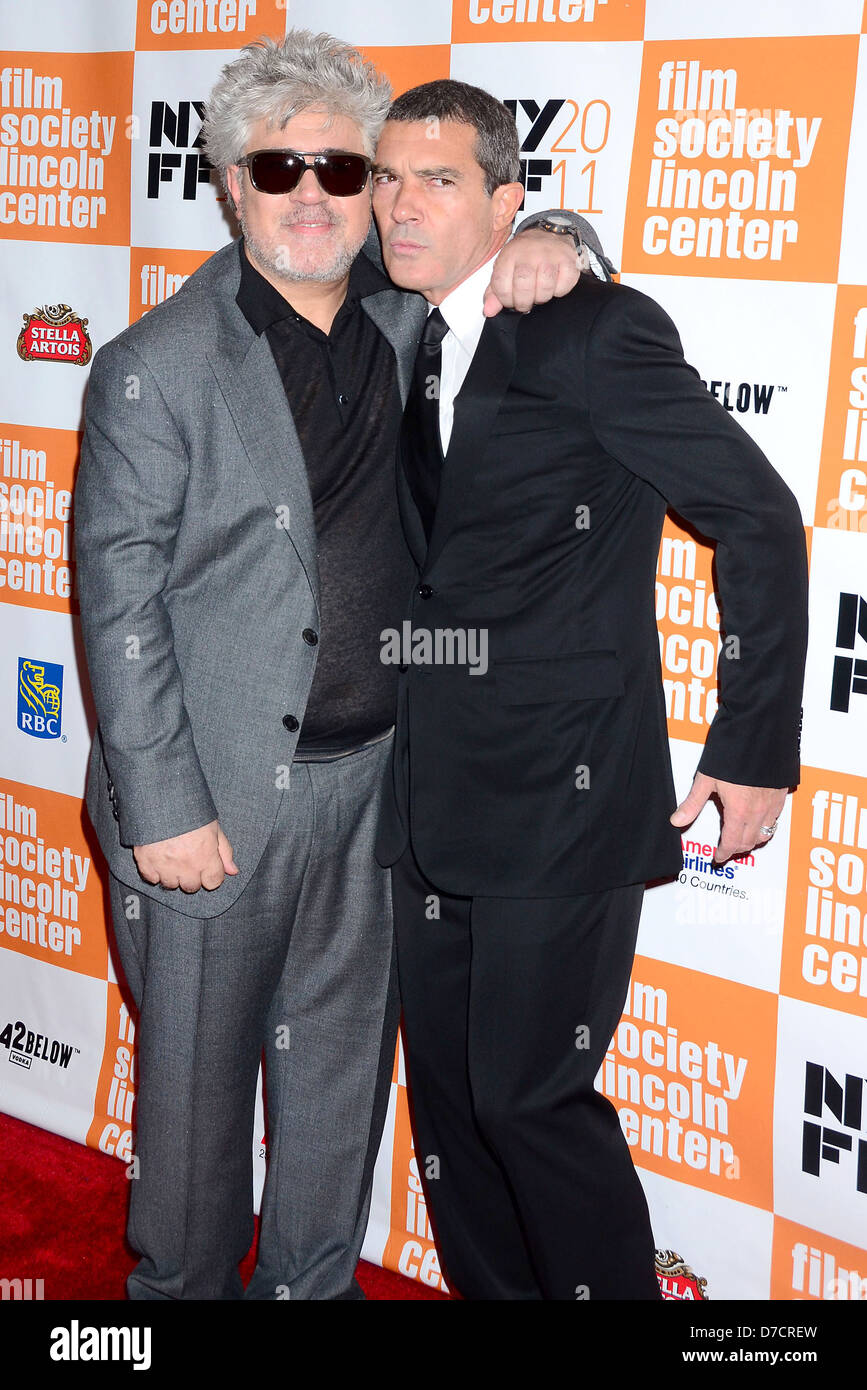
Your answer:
[374,81,806,1300]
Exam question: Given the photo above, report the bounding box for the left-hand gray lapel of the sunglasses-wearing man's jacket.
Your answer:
[207,315,320,609]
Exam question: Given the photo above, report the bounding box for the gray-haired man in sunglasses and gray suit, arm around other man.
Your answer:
[75,31,577,1300]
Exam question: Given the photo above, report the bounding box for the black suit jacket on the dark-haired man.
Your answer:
[378,278,806,897]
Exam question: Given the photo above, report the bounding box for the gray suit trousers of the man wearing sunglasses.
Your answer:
[105,738,399,1300]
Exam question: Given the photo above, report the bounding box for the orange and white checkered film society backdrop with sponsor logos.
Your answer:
[0,0,867,1300]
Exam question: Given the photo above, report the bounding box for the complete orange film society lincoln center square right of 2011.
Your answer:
[622,35,859,282]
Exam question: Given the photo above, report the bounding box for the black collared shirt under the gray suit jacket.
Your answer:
[236,240,415,758]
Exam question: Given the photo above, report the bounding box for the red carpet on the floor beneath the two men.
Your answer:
[0,1115,445,1301]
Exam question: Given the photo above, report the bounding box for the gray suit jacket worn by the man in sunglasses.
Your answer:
[75,238,425,917]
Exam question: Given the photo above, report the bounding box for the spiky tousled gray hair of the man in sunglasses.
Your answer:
[203,29,392,202]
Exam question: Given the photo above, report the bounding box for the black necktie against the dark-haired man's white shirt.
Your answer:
[400,309,449,541]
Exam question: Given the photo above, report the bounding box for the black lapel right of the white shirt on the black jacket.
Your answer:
[422,309,522,570]
